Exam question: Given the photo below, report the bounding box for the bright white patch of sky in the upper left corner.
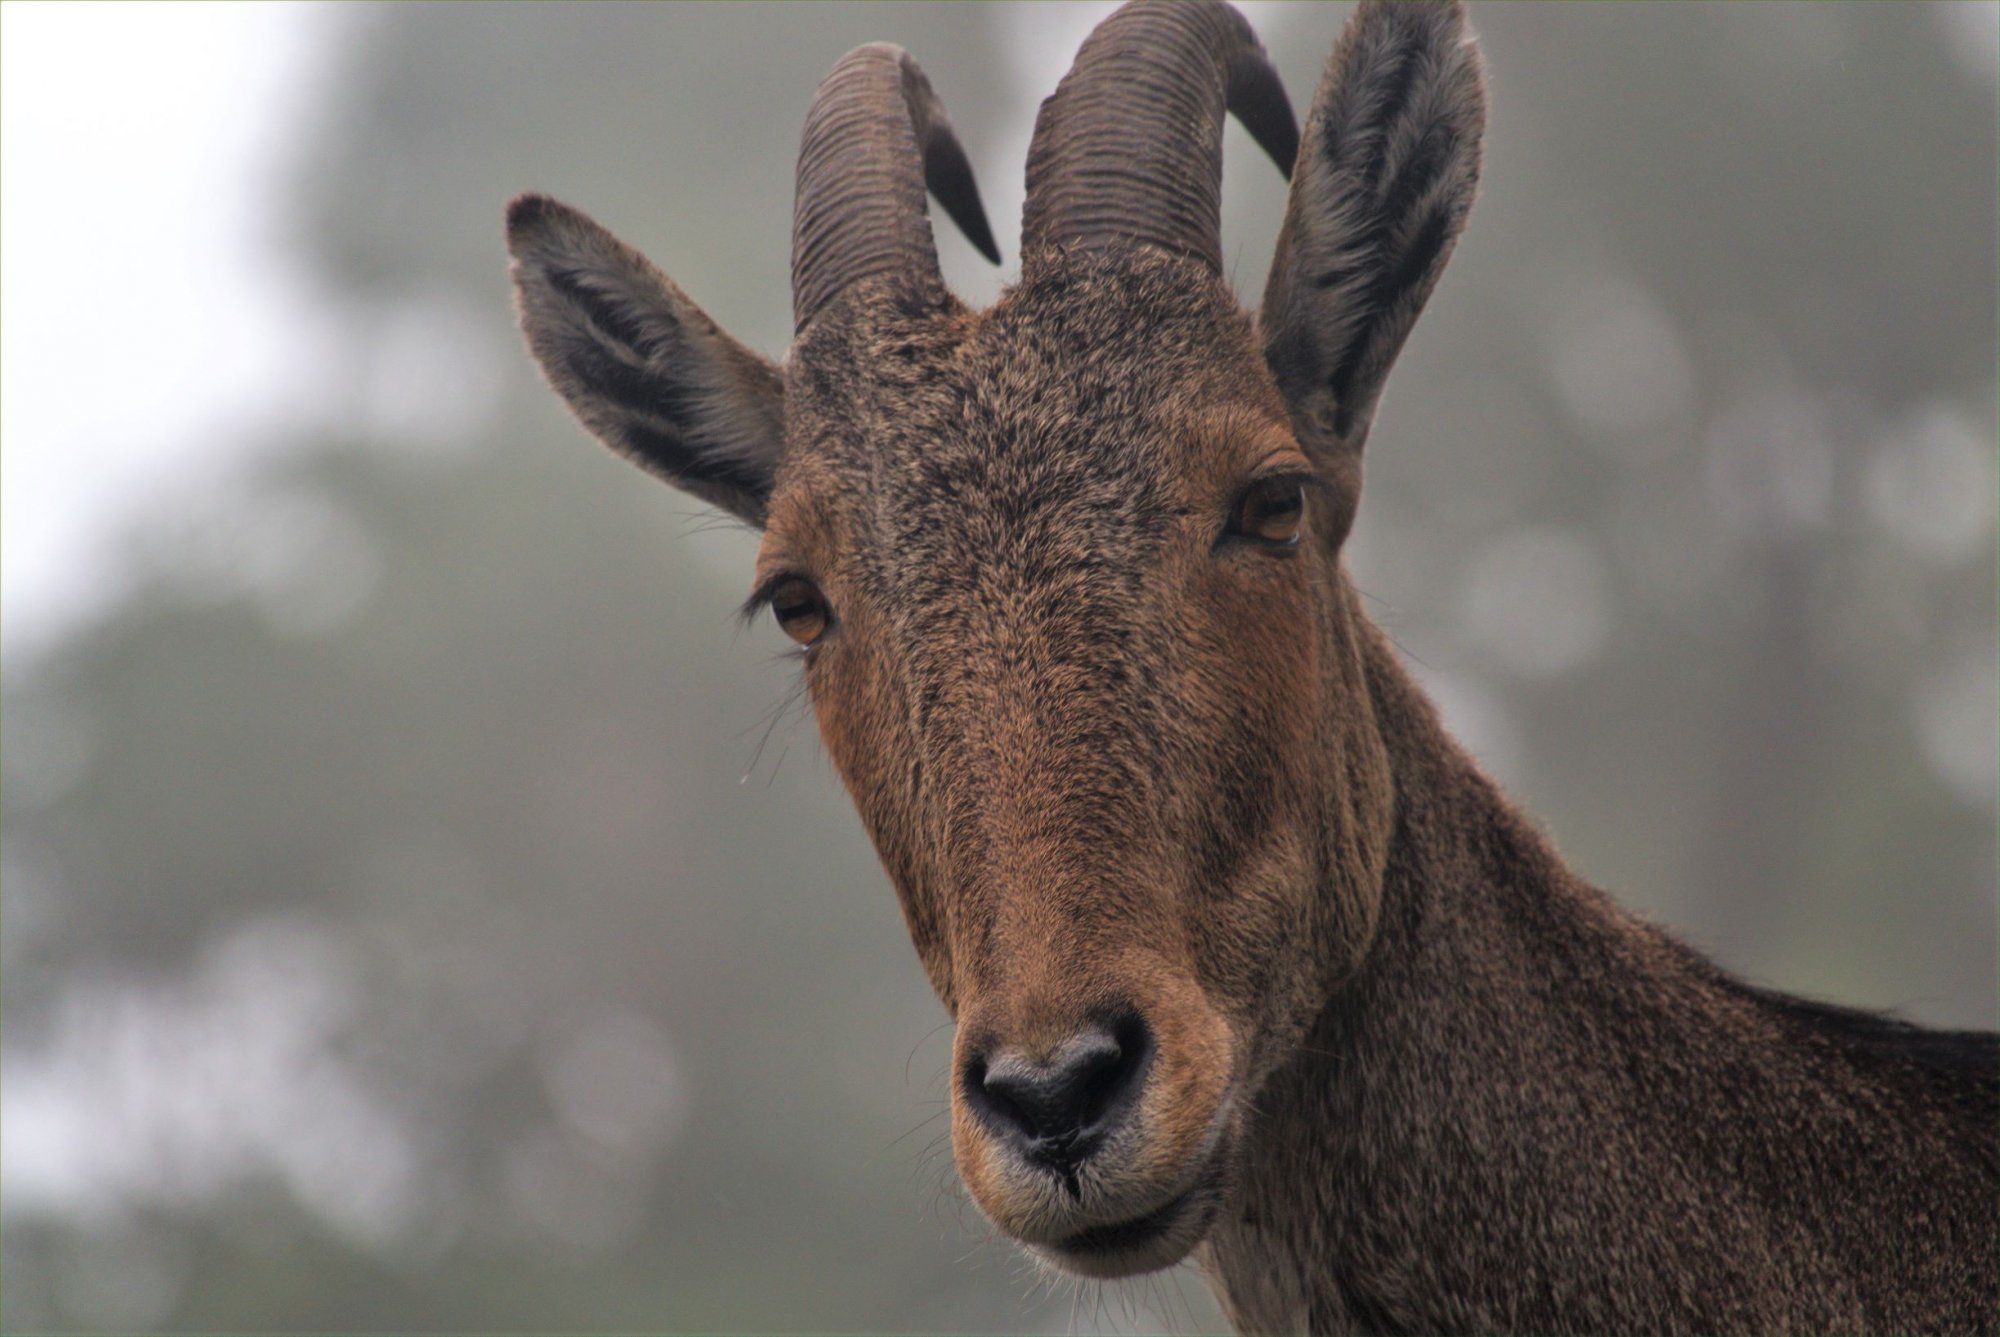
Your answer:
[0,0,334,662]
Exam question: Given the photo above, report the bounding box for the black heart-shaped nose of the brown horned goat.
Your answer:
[962,1013,1152,1175]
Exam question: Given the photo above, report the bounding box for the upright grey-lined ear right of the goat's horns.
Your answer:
[1258,0,1486,532]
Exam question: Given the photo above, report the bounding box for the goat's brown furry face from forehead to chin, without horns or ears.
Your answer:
[758,252,1370,1271]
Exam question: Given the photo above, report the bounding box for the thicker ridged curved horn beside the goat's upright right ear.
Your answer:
[1020,0,1298,272]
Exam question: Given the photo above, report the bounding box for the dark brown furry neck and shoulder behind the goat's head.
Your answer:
[1206,620,2000,1333]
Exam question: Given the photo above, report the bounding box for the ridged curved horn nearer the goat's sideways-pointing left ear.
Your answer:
[792,42,1000,328]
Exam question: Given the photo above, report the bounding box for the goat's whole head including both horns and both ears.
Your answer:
[508,0,1484,1277]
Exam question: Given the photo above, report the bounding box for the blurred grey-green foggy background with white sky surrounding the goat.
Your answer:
[0,4,2000,1331]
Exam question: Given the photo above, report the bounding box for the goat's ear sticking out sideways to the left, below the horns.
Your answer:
[506,194,784,528]
